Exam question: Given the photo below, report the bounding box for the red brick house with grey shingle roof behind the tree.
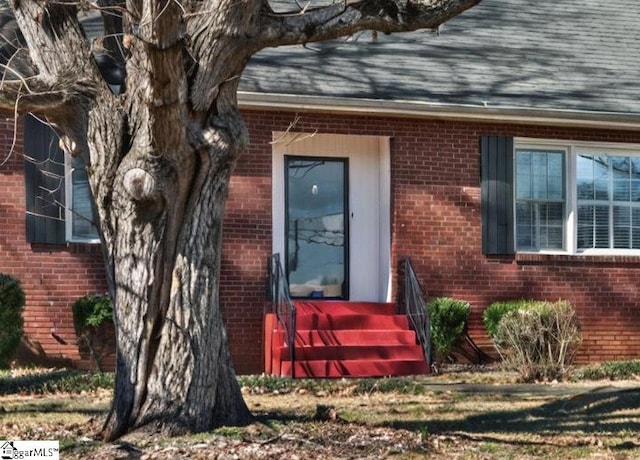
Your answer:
[0,0,640,373]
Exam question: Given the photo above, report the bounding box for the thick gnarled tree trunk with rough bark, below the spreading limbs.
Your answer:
[89,85,251,439]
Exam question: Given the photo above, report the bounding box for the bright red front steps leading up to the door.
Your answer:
[264,300,429,378]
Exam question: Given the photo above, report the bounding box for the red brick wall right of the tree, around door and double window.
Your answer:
[234,111,640,371]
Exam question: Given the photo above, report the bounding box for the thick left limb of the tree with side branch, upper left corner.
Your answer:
[0,0,120,155]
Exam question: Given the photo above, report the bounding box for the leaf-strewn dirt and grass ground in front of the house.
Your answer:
[0,377,640,460]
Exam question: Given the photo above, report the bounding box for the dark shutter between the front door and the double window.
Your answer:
[480,136,514,254]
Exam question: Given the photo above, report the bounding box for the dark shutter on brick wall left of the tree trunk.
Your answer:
[24,115,66,244]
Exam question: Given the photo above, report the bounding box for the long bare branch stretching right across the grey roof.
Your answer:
[255,0,481,49]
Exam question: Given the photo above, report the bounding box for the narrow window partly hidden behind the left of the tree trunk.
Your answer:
[65,155,100,242]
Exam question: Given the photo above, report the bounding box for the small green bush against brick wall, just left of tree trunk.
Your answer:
[72,295,113,371]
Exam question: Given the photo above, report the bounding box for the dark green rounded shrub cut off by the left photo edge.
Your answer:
[0,274,24,367]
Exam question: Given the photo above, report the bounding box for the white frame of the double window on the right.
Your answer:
[513,138,640,256]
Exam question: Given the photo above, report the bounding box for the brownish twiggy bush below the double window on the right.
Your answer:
[493,300,581,381]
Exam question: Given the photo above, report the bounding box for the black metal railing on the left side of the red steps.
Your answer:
[269,254,296,378]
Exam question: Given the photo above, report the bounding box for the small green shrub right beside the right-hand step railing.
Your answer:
[427,297,471,363]
